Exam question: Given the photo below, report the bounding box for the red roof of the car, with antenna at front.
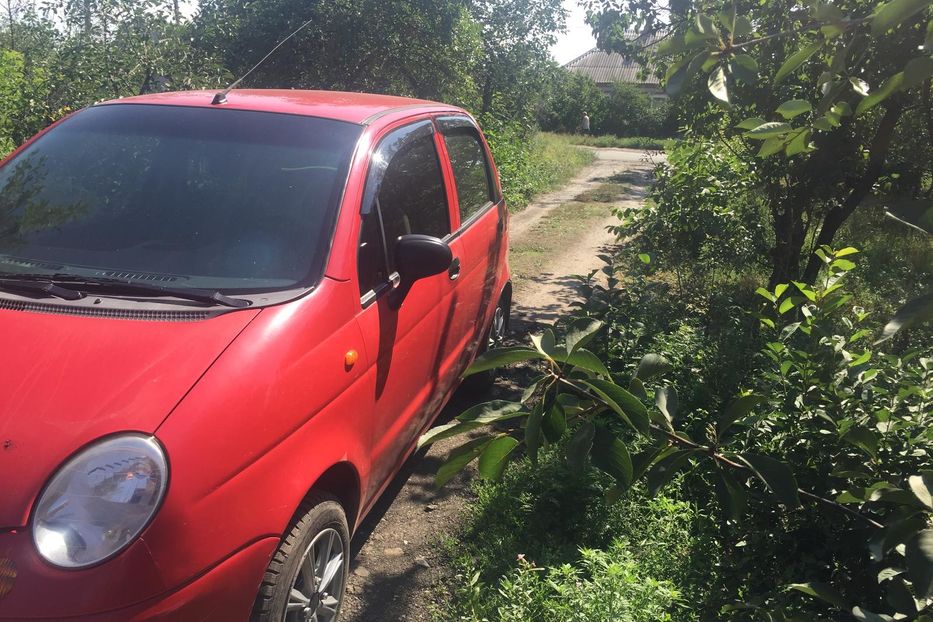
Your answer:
[100,89,463,125]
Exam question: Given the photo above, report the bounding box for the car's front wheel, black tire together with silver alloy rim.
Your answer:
[251,495,350,622]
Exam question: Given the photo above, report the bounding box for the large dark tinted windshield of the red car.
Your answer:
[0,104,362,293]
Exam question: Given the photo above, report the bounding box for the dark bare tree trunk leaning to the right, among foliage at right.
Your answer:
[803,102,904,283]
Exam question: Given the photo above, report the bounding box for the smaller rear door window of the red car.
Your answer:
[444,126,495,222]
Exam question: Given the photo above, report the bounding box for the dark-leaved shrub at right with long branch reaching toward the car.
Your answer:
[424,247,933,620]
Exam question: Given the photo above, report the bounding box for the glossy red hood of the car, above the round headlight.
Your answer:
[0,309,259,527]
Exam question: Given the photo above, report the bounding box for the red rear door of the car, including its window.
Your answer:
[437,116,508,374]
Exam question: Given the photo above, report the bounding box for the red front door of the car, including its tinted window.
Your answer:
[358,120,455,494]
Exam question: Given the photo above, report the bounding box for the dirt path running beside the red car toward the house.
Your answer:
[342,149,651,622]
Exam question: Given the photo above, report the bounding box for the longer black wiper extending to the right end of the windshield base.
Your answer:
[0,274,253,309]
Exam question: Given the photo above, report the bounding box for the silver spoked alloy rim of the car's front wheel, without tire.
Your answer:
[282,529,347,622]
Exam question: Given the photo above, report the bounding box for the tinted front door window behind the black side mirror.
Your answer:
[358,121,450,294]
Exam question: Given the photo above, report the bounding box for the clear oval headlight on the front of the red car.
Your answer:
[32,434,168,568]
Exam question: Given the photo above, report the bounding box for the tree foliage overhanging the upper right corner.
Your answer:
[587,0,933,285]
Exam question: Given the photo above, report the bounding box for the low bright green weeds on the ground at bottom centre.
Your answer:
[444,447,717,621]
